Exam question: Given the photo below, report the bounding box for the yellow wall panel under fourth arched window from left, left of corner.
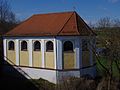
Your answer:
[45,52,55,69]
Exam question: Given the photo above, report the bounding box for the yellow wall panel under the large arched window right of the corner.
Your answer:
[64,52,76,69]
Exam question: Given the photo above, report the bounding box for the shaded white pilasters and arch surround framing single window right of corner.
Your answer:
[56,36,82,69]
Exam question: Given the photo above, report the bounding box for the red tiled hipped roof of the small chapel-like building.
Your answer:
[5,12,94,36]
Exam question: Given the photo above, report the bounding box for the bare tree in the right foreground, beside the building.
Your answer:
[94,17,120,90]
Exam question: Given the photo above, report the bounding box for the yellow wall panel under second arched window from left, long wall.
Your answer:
[20,51,29,66]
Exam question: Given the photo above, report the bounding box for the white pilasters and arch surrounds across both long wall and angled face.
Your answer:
[4,36,81,69]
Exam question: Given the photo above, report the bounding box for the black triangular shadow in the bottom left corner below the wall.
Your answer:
[0,61,43,90]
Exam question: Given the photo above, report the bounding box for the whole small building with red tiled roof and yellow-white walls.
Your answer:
[3,12,96,83]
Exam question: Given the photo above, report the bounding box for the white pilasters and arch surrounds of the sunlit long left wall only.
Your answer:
[3,37,57,68]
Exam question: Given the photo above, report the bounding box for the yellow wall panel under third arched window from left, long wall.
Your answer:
[33,51,42,67]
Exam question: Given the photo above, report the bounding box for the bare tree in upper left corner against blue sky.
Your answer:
[0,0,17,33]
